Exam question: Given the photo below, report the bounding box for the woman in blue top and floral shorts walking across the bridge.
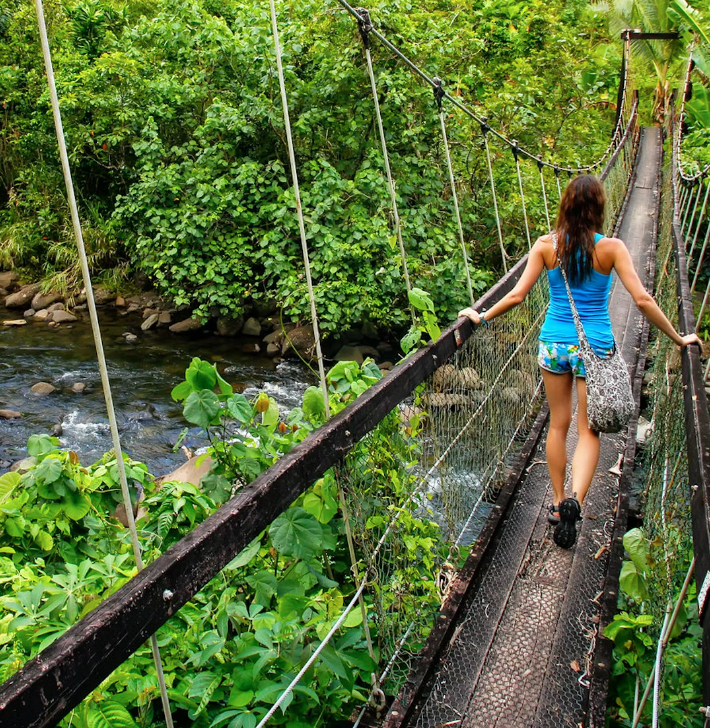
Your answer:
[459,175,700,548]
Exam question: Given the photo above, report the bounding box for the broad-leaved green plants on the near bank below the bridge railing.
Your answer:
[0,359,444,728]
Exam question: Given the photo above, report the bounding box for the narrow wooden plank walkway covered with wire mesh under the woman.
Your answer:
[398,128,662,728]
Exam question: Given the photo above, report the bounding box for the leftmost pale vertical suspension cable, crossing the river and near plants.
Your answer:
[35,0,173,728]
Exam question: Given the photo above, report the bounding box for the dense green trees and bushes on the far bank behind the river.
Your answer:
[0,0,619,335]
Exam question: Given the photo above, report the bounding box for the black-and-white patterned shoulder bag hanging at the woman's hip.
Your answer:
[554,237,636,432]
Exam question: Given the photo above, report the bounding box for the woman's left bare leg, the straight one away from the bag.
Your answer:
[542,369,586,505]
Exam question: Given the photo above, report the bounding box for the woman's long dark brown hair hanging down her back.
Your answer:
[555,174,606,284]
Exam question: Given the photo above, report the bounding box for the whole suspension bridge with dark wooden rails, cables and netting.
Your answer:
[0,0,710,728]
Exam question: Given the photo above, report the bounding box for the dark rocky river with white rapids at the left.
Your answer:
[0,307,315,475]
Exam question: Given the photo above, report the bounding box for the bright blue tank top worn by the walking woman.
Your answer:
[540,233,614,349]
